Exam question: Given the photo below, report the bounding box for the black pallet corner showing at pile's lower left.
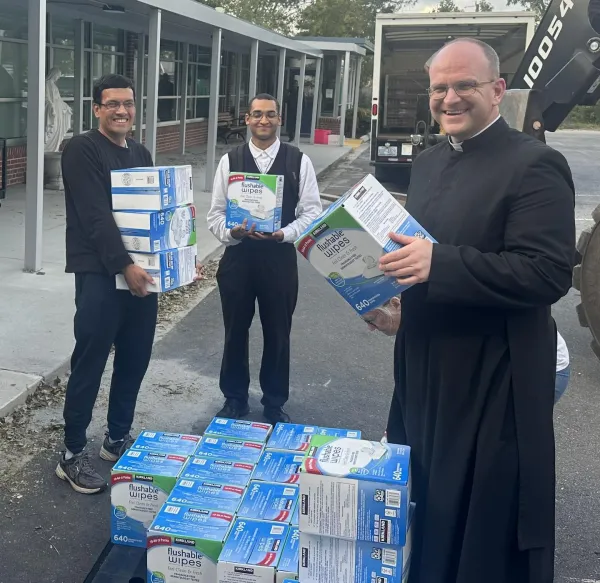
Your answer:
[83,542,146,583]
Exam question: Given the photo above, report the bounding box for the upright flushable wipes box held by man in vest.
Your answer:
[225,172,284,233]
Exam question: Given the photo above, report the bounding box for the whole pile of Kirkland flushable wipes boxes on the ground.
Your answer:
[111,417,413,583]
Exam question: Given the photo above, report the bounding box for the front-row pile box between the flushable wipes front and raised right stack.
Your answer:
[216,518,290,583]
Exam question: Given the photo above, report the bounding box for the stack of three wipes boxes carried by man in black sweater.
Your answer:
[111,165,198,293]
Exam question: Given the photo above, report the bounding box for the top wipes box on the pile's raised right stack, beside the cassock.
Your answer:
[299,436,410,546]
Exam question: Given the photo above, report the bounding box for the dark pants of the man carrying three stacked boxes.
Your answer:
[64,273,158,454]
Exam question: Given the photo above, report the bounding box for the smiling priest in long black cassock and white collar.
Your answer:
[380,39,575,583]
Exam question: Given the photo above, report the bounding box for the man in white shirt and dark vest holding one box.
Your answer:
[207,94,322,423]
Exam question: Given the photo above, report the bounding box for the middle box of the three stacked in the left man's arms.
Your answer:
[113,204,197,253]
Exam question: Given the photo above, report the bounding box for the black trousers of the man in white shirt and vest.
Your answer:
[217,240,298,407]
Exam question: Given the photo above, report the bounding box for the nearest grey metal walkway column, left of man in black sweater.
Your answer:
[25,0,46,271]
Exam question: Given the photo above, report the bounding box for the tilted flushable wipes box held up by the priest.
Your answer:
[295,174,436,314]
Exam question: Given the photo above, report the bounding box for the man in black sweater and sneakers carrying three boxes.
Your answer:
[56,75,158,494]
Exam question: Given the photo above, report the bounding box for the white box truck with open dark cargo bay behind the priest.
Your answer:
[371,12,536,182]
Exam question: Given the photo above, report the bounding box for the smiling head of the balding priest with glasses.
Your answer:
[429,41,506,141]
